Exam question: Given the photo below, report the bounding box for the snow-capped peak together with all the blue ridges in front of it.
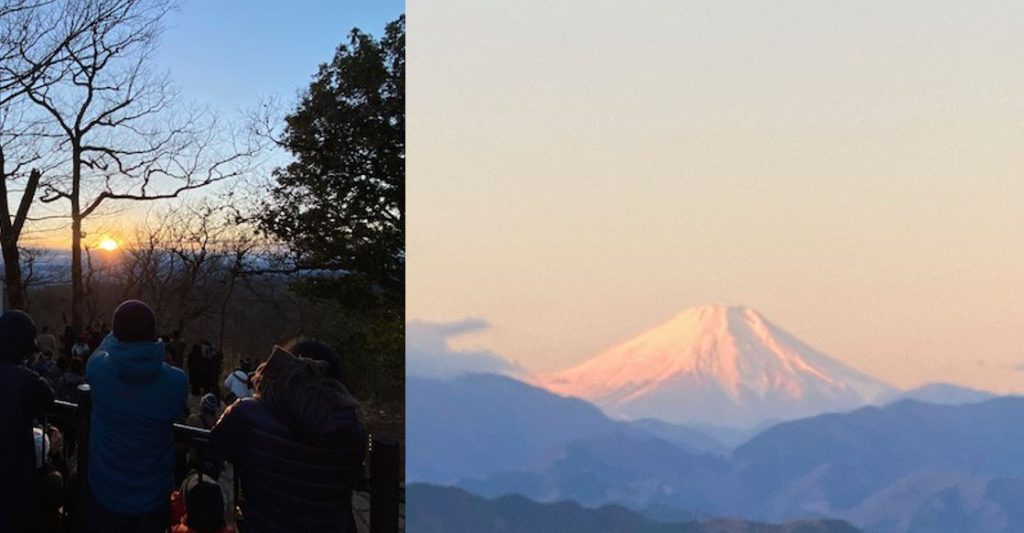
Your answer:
[407,307,1007,533]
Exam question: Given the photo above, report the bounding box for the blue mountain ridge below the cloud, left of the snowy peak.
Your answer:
[406,374,726,484]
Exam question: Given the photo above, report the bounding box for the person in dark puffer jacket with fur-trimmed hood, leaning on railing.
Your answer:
[210,347,367,533]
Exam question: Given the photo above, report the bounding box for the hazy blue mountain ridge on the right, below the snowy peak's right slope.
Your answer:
[459,397,1024,533]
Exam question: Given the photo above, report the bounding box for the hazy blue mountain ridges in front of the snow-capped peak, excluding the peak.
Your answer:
[407,306,1024,533]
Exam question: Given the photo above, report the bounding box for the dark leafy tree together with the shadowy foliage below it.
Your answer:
[256,15,406,399]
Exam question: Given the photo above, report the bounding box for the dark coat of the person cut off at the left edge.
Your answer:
[0,360,53,531]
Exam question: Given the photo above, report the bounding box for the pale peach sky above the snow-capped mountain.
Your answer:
[407,0,1024,393]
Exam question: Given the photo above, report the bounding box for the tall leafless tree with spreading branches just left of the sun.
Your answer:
[22,0,259,328]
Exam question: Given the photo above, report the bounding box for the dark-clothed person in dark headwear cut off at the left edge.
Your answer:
[0,311,53,531]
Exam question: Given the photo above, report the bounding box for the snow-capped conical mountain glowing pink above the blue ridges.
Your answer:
[534,306,892,426]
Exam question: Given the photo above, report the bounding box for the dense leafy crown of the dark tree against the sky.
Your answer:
[259,16,406,296]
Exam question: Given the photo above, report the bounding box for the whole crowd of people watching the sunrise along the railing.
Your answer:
[0,301,367,533]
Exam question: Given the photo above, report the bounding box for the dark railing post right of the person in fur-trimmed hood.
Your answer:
[370,435,400,533]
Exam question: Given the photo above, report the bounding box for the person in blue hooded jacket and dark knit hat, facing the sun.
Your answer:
[85,300,188,532]
